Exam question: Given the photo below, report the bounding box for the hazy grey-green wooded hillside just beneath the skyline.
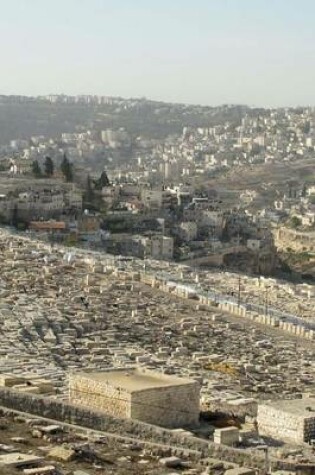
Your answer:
[0,96,253,145]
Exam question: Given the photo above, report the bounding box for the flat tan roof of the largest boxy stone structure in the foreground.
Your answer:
[75,368,198,392]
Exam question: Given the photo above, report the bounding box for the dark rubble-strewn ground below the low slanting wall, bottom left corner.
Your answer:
[0,412,207,475]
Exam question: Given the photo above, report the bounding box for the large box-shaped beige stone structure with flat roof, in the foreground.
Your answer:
[69,368,200,428]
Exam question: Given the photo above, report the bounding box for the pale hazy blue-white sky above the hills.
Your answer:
[0,0,315,107]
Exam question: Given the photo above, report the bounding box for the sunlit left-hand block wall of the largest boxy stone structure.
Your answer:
[69,374,131,418]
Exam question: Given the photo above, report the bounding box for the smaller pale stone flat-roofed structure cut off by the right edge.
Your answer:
[257,398,315,444]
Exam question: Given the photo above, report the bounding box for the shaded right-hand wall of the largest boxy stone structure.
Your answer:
[131,382,200,428]
